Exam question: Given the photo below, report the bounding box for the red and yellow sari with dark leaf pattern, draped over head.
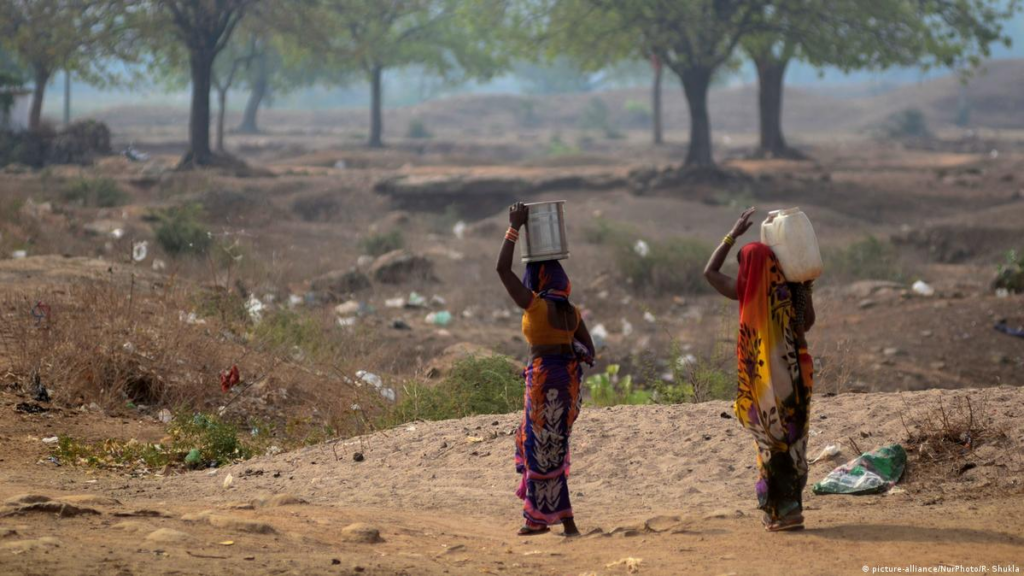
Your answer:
[734,243,814,521]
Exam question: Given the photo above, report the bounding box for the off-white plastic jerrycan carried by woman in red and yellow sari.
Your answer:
[761,208,823,282]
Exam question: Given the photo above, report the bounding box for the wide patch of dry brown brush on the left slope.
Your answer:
[0,274,383,436]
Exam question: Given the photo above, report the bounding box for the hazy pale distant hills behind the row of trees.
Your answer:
[92,59,1024,136]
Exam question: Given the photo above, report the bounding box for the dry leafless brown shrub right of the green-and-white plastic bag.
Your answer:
[900,389,1008,480]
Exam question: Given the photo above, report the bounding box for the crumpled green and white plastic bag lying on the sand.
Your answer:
[813,444,906,494]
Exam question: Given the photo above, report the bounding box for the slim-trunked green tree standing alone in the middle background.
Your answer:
[301,0,502,148]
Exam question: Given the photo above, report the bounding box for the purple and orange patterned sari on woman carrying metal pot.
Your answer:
[515,261,583,528]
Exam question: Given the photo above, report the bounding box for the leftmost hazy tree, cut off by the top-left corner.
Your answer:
[0,0,123,129]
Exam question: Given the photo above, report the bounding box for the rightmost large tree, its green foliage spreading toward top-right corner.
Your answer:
[742,0,1018,158]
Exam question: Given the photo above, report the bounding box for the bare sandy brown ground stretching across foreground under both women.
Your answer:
[0,386,1024,575]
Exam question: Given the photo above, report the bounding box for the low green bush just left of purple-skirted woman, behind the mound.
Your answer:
[383,356,523,425]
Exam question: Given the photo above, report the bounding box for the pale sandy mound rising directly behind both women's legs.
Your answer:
[157,386,1024,522]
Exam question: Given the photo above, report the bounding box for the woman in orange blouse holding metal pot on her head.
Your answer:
[498,203,594,536]
